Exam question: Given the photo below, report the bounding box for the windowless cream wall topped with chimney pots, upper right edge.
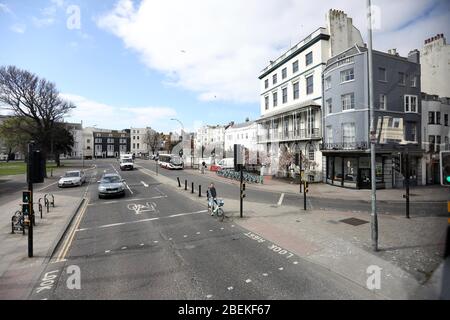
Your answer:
[420,34,450,97]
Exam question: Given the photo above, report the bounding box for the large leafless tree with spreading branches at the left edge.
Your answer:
[0,66,75,174]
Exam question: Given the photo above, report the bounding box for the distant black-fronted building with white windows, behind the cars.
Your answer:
[93,129,130,158]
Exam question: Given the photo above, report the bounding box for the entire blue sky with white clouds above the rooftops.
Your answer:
[0,0,450,131]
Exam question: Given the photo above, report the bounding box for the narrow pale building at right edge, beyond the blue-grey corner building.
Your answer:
[422,93,450,184]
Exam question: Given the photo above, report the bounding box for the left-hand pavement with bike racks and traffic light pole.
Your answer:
[0,164,96,300]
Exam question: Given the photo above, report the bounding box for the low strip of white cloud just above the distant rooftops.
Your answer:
[61,94,176,130]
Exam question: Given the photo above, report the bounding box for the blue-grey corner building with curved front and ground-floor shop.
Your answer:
[322,45,422,188]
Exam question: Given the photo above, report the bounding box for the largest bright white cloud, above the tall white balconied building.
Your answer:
[97,0,449,102]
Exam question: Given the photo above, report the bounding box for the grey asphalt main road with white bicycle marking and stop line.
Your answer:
[30,160,374,300]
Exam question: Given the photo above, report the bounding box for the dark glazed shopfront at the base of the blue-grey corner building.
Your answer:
[326,154,386,189]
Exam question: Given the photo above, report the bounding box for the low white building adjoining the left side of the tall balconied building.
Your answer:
[225,121,258,155]
